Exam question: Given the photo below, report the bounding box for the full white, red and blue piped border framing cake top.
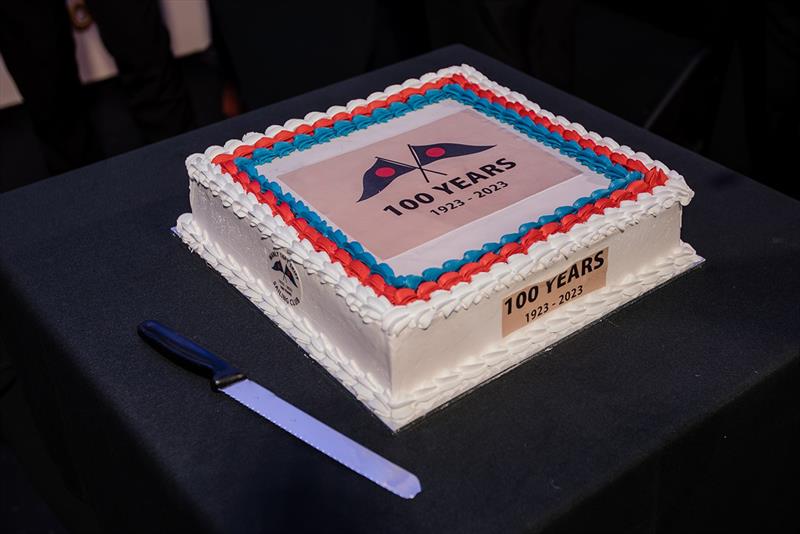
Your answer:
[186,65,693,335]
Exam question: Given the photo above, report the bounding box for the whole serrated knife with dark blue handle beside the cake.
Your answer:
[139,321,422,499]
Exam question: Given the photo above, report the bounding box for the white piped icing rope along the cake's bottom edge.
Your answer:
[176,214,703,430]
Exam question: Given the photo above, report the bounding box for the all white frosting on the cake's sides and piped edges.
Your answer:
[177,65,702,429]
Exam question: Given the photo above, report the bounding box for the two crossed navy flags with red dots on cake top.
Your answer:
[357,143,495,202]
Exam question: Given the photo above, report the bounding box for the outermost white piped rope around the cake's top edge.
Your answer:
[187,66,693,334]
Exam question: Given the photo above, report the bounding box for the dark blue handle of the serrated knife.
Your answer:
[139,321,247,389]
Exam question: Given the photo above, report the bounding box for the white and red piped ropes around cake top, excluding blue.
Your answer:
[187,65,693,335]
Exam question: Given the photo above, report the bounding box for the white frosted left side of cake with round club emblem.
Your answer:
[179,181,389,415]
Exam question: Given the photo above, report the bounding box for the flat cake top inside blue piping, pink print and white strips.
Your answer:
[256,99,610,276]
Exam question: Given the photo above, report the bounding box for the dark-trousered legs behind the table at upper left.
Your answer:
[0,0,194,174]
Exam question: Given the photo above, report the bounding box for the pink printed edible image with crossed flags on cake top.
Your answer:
[272,107,582,268]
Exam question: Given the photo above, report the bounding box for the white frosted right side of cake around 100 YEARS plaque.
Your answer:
[391,204,699,422]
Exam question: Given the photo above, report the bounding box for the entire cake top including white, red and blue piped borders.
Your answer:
[194,65,692,328]
